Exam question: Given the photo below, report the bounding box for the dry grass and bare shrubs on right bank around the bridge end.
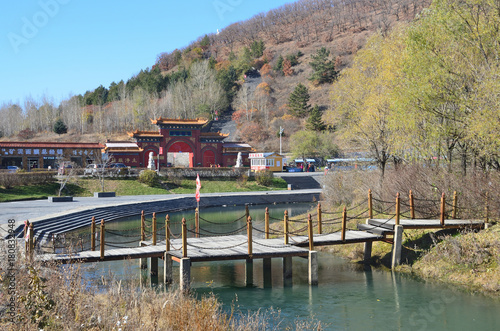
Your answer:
[318,166,500,295]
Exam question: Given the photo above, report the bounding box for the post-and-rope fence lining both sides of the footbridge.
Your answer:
[24,190,489,258]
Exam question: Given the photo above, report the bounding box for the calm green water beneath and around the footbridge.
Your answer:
[69,204,500,331]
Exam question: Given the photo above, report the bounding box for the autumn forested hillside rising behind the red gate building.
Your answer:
[0,0,429,153]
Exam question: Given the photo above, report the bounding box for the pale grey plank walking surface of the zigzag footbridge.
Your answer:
[38,219,484,263]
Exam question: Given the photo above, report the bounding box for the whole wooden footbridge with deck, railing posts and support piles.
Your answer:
[26,192,485,289]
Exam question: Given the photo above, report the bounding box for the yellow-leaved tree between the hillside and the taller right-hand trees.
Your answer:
[325,33,403,179]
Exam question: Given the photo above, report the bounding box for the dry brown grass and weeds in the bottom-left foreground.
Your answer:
[0,245,322,331]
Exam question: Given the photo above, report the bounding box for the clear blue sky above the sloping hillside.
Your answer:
[0,0,293,106]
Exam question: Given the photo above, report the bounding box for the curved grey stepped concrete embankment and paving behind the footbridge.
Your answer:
[1,189,321,241]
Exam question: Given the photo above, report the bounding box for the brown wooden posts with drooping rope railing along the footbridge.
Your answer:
[25,191,488,258]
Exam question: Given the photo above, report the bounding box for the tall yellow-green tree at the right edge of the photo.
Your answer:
[397,0,500,172]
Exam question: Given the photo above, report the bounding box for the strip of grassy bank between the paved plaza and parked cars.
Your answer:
[0,178,287,202]
